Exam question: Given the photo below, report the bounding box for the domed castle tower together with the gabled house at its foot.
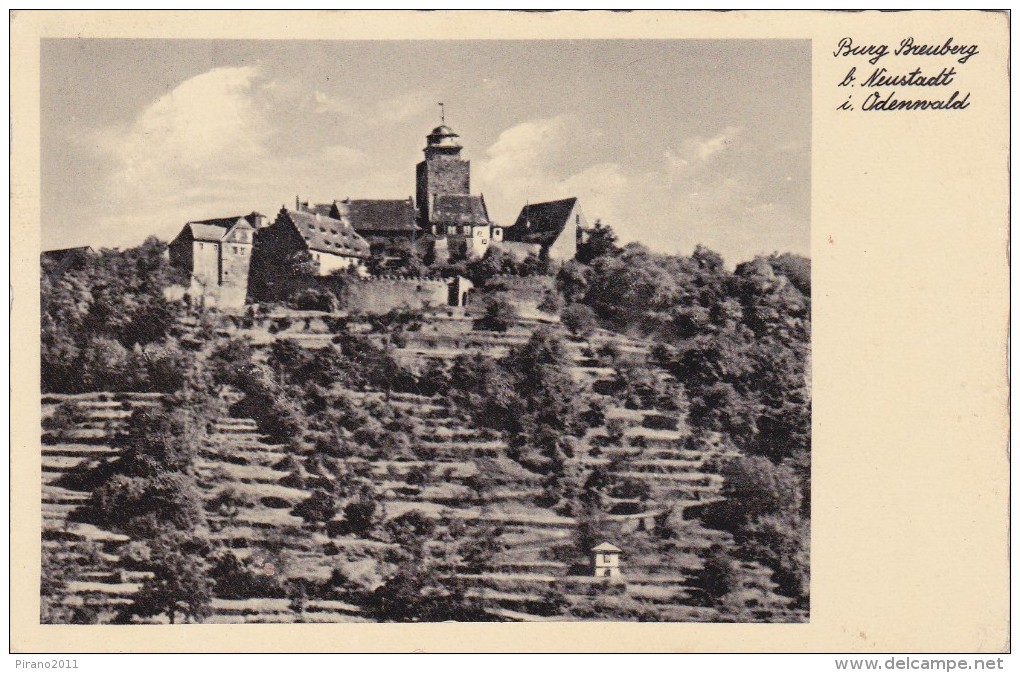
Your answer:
[416,124,503,259]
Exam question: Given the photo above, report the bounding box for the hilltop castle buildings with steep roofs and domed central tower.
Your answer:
[169,123,589,307]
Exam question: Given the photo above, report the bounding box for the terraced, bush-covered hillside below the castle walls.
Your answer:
[41,239,810,623]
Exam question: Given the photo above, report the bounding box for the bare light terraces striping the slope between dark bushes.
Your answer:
[42,311,805,623]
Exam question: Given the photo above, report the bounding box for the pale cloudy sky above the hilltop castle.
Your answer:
[41,39,811,264]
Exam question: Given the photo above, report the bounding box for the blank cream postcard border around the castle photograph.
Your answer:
[10,11,1010,653]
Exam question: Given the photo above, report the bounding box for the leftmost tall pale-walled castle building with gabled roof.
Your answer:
[168,212,265,307]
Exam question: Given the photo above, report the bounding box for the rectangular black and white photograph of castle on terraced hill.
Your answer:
[33,39,812,625]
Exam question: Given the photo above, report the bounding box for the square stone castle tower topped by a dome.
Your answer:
[415,124,471,229]
